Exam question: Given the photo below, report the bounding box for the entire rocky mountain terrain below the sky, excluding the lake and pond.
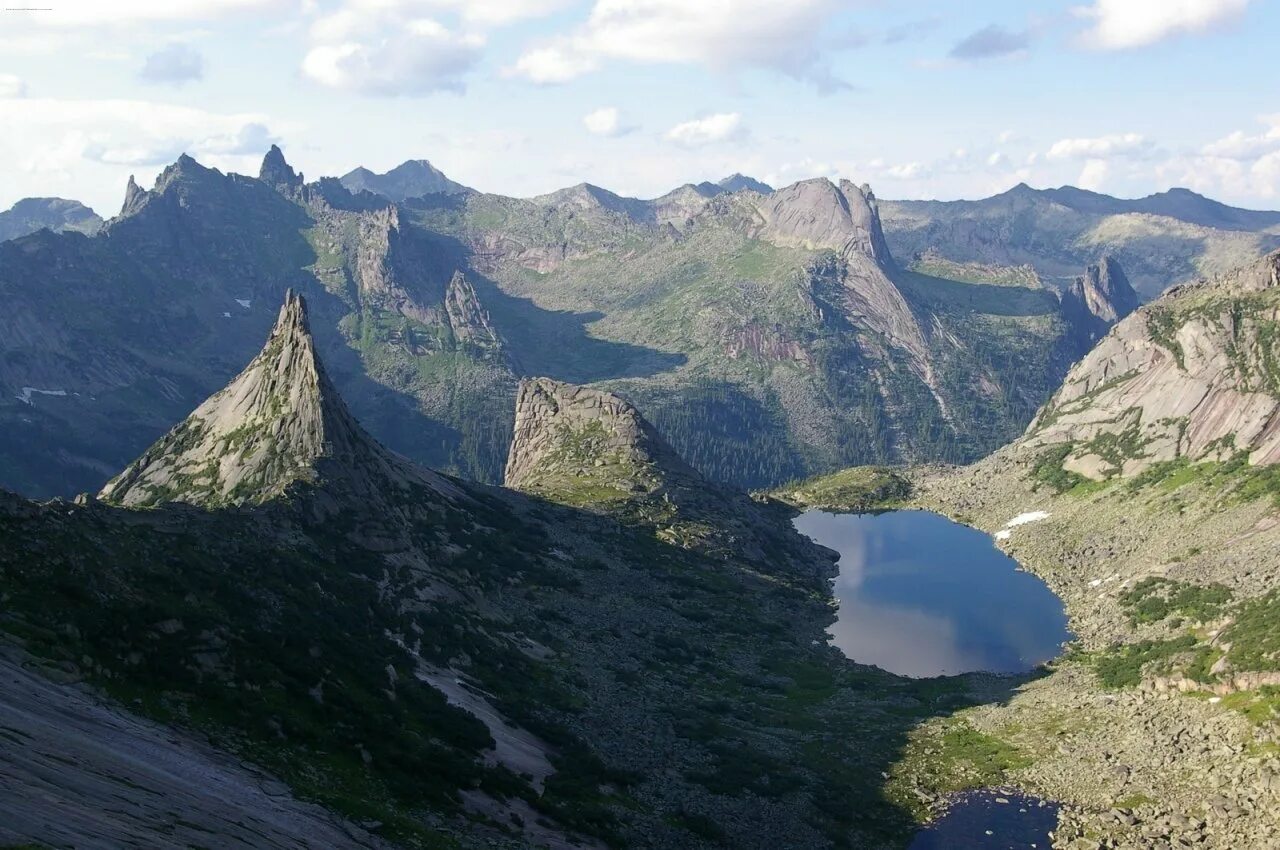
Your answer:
[0,148,1280,850]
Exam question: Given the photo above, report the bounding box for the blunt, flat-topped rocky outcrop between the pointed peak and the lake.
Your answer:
[503,378,696,492]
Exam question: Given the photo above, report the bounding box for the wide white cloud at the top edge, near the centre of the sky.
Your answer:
[508,0,844,90]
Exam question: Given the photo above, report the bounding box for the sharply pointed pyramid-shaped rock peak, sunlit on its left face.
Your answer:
[100,292,447,507]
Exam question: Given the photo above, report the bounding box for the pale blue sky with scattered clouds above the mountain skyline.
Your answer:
[0,0,1280,215]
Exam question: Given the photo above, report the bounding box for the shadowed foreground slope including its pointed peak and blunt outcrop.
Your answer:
[0,294,991,847]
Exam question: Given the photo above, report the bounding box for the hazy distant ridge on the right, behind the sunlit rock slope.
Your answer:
[881,184,1280,298]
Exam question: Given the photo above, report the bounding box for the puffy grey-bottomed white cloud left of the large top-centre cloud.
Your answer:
[302,13,484,95]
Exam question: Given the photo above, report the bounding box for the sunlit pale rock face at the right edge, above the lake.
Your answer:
[1023,252,1280,479]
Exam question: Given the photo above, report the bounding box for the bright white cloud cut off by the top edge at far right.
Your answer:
[1073,0,1251,50]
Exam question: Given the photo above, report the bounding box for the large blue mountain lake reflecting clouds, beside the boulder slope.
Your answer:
[795,511,1070,676]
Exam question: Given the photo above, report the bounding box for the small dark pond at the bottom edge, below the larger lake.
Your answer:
[908,791,1057,850]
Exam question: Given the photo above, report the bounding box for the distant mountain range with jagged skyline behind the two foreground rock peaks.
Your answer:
[0,148,1272,504]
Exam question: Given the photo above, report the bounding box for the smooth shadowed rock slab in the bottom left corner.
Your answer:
[0,647,388,849]
